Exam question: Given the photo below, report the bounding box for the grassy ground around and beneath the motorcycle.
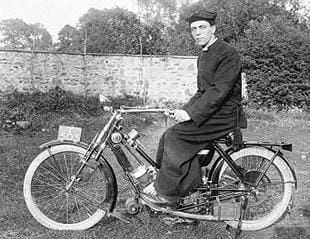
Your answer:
[0,111,310,239]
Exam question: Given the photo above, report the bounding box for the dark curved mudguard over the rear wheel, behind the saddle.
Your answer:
[208,142,297,189]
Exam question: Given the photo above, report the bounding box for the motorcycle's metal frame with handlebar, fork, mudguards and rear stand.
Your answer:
[29,105,297,238]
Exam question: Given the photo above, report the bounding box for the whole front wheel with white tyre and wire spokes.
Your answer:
[24,144,117,230]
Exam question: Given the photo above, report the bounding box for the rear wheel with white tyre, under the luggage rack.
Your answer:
[214,147,295,231]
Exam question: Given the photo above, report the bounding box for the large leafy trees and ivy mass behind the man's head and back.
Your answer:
[169,0,310,110]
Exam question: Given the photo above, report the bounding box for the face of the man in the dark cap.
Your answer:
[190,20,215,46]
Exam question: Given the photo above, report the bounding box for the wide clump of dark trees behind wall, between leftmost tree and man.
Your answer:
[58,7,167,54]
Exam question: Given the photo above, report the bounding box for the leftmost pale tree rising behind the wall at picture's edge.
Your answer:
[0,19,52,50]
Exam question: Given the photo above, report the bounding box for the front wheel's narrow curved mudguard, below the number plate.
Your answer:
[39,140,117,213]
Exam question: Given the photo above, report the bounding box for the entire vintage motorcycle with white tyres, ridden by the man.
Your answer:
[24,107,297,237]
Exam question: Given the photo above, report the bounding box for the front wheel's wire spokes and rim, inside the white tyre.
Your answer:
[31,151,109,224]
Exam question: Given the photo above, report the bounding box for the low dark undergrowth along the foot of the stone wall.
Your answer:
[0,87,152,132]
